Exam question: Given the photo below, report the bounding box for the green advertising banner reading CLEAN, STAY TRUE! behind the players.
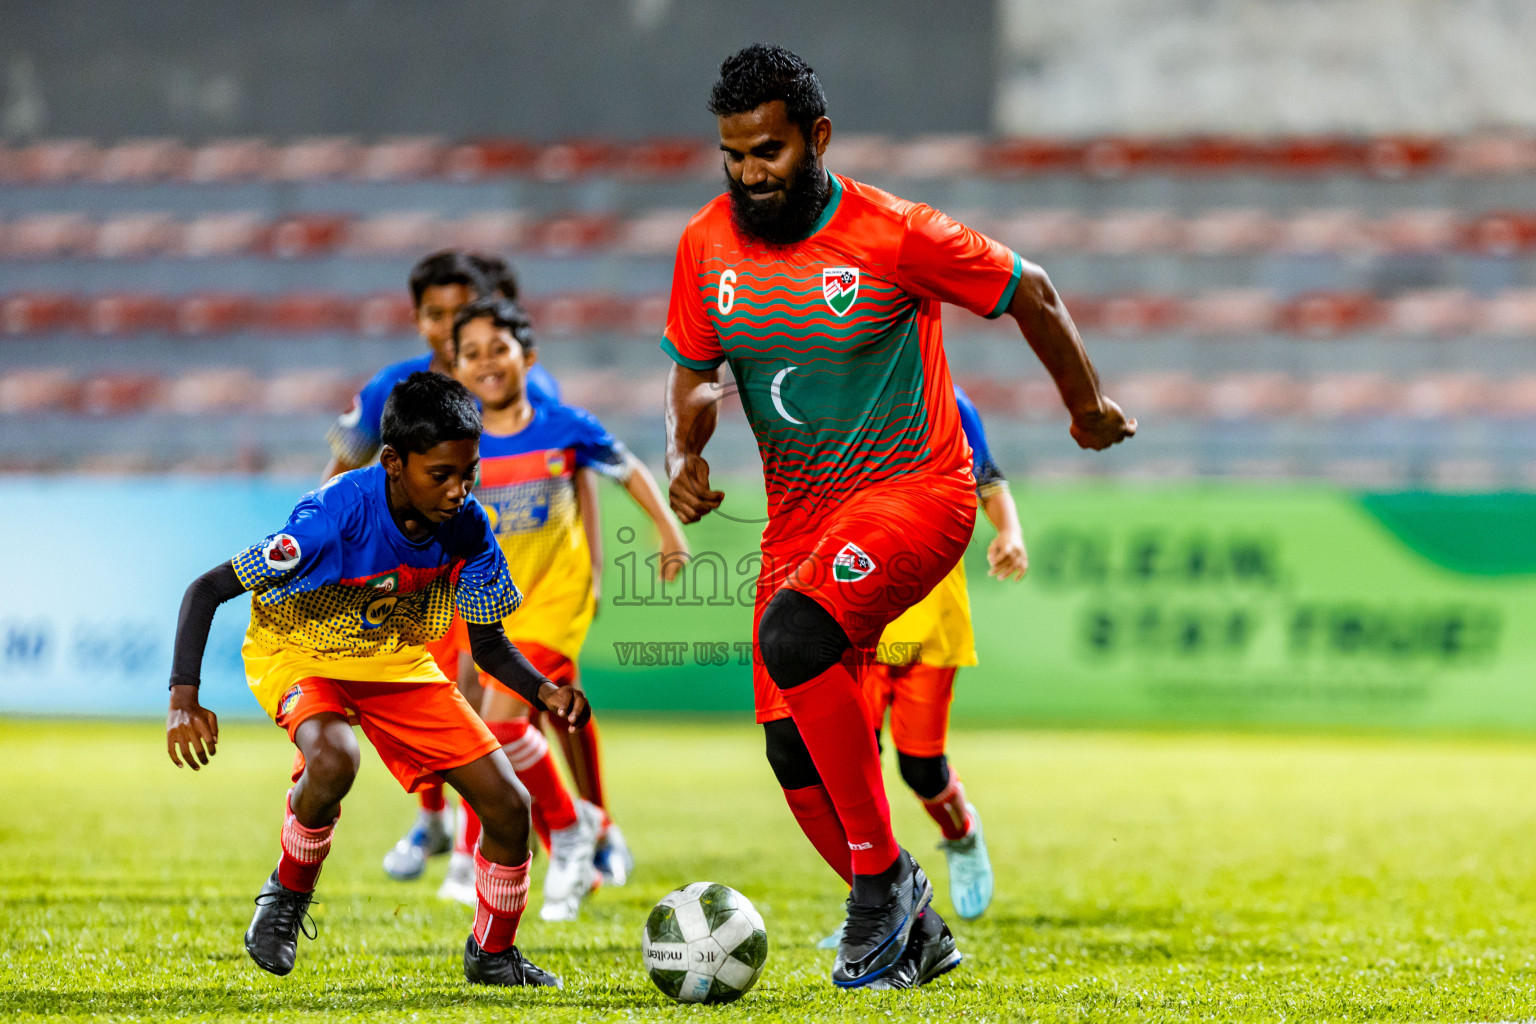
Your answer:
[582,482,1536,729]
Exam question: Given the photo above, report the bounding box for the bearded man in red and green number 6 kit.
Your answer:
[662,45,1135,987]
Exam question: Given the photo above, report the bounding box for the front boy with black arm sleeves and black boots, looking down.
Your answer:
[166,373,587,986]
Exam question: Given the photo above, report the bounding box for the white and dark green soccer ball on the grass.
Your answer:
[641,881,768,1003]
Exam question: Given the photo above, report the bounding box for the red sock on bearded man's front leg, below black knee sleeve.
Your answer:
[782,651,900,875]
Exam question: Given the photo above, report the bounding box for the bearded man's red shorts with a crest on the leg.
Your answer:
[753,473,975,722]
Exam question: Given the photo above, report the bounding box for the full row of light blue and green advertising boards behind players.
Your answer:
[0,477,1536,731]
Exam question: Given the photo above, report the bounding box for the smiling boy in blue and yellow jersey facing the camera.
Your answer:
[453,299,688,920]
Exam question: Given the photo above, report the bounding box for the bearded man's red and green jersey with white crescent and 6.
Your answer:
[662,175,1023,519]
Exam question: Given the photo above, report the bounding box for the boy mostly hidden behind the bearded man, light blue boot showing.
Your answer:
[863,387,1029,920]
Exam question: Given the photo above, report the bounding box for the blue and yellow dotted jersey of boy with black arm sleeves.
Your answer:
[233,465,522,659]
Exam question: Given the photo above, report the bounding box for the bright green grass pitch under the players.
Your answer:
[9,720,1536,1022]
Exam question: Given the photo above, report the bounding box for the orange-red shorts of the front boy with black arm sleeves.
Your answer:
[276,676,501,792]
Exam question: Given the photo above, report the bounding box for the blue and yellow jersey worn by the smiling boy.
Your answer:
[475,405,630,594]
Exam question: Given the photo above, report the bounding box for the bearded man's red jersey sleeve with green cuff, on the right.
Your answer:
[895,204,1025,318]
